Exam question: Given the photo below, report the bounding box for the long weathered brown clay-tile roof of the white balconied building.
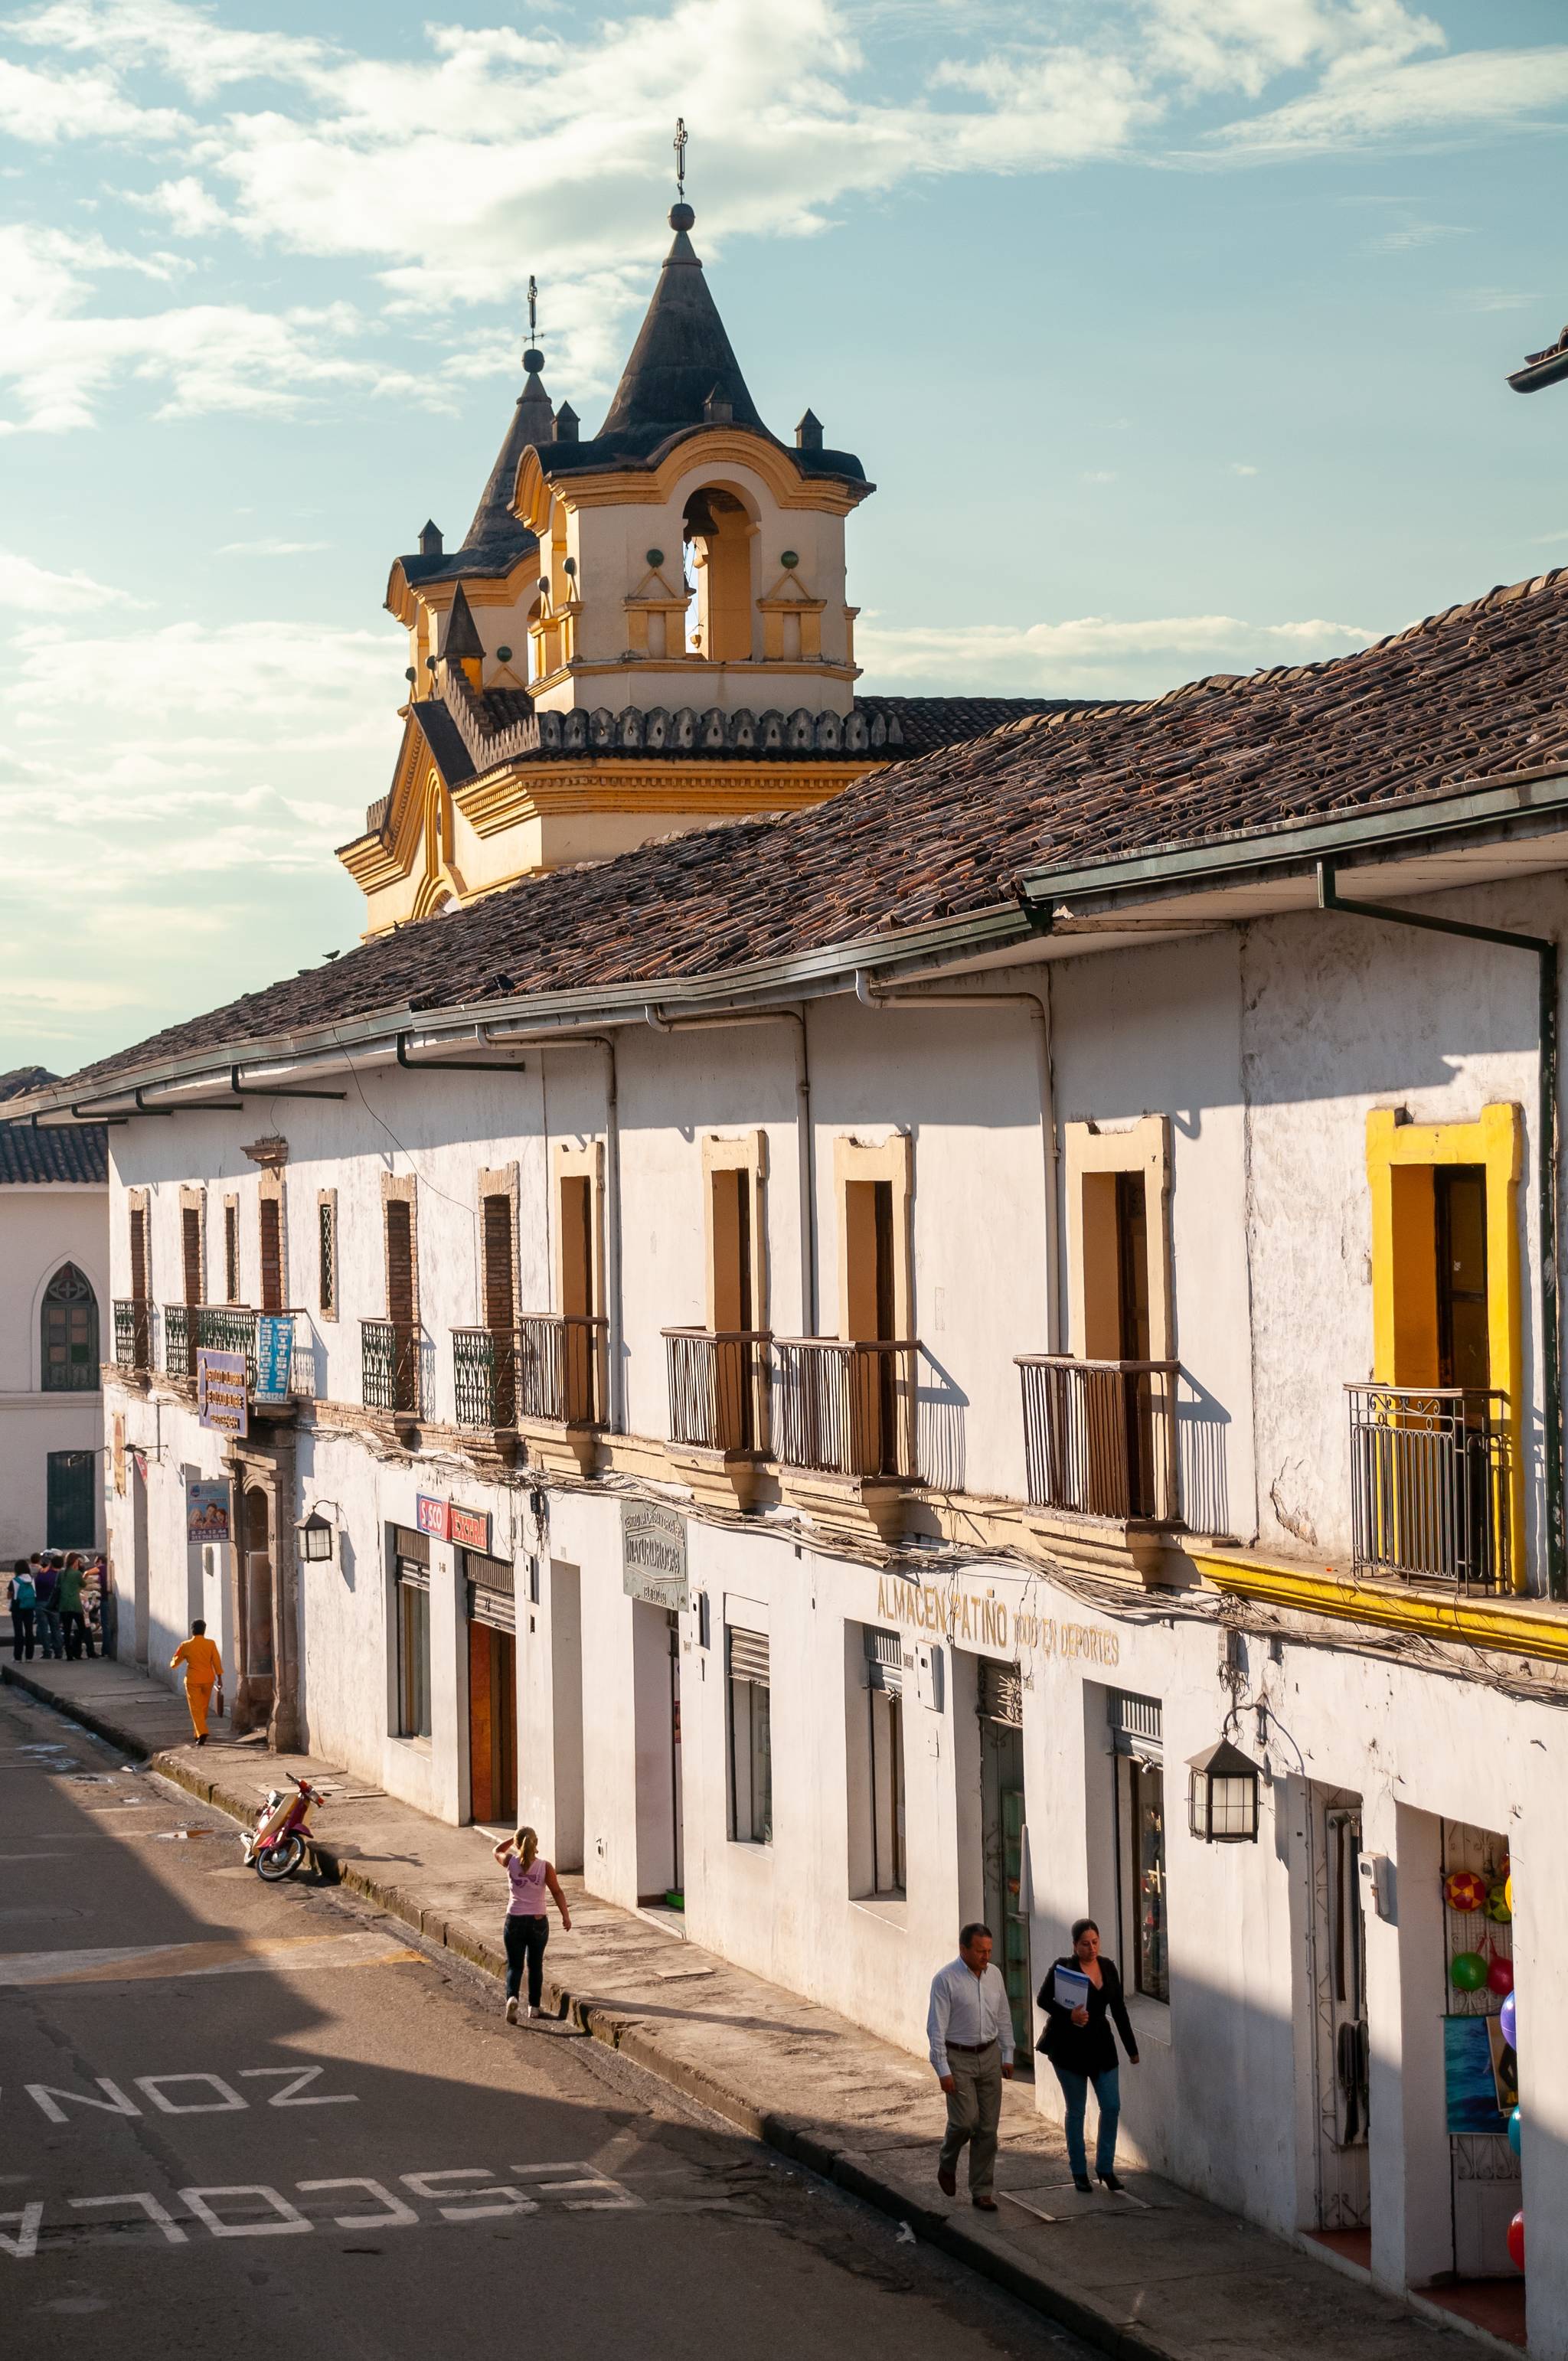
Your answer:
[61,571,1568,1084]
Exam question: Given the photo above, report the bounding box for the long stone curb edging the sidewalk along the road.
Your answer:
[0,1664,1237,2361]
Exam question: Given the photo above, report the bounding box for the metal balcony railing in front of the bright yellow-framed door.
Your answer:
[1346,1386,1511,1592]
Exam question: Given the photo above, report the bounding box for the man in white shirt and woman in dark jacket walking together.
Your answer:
[926,1919,1138,2212]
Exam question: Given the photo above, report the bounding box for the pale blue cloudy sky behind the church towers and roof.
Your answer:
[0,0,1568,1069]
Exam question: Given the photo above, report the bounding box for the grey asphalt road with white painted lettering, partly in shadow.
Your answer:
[0,1690,1086,2361]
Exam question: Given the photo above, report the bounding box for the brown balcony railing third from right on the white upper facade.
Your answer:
[773,1337,921,1483]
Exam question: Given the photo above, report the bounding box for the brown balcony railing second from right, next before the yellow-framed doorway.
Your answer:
[1018,1353,1181,1525]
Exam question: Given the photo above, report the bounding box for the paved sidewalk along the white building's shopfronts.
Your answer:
[0,1660,1490,2361]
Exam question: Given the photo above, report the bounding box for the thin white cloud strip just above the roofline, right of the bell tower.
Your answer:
[855,614,1377,697]
